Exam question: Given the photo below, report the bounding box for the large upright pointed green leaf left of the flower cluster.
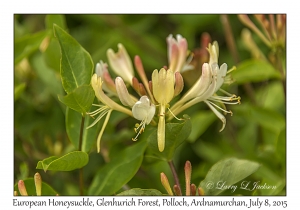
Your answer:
[54,24,94,93]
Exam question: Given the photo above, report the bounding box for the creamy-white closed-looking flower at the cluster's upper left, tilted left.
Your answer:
[107,44,134,84]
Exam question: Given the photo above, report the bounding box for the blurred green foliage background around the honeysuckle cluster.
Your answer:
[13,14,286,195]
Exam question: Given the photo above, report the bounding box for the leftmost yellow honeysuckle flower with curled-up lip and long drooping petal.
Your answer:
[87,74,132,153]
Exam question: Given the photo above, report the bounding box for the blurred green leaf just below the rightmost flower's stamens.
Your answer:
[187,111,216,143]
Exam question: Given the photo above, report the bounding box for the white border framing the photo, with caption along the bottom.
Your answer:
[0,0,300,209]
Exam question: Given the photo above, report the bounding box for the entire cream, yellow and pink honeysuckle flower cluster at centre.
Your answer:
[88,35,240,152]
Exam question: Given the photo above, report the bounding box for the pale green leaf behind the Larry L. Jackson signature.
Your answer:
[199,158,260,195]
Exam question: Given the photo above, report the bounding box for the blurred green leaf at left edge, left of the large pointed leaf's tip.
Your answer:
[14,31,49,64]
